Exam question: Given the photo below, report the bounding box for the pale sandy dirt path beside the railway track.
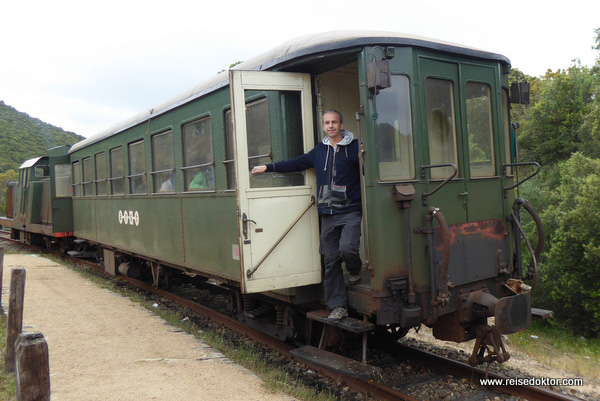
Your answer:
[2,254,292,401]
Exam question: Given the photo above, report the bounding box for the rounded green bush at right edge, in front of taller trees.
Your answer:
[523,153,600,337]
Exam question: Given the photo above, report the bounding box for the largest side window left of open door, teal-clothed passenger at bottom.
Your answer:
[181,118,215,191]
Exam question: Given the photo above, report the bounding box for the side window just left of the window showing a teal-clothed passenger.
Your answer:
[151,131,175,193]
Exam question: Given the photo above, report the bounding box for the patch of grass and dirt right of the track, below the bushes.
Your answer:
[510,320,600,380]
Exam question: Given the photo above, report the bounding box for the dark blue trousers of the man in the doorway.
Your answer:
[320,212,362,308]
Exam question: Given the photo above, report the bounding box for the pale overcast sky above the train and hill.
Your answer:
[0,0,600,137]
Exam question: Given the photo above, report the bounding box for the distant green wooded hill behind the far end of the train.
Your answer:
[0,101,84,173]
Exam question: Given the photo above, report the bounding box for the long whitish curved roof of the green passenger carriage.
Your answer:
[69,31,510,153]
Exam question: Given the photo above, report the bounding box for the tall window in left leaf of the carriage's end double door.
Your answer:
[425,78,460,179]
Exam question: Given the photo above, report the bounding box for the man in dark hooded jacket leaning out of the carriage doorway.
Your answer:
[252,110,362,322]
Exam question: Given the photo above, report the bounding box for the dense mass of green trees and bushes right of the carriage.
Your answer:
[512,29,600,337]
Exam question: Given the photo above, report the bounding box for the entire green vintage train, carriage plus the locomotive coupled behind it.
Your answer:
[0,31,543,372]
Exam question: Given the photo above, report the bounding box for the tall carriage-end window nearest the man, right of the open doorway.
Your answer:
[377,75,415,181]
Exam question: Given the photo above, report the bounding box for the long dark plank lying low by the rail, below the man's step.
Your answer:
[290,345,382,380]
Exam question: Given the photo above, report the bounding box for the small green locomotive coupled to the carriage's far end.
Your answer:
[0,146,73,247]
